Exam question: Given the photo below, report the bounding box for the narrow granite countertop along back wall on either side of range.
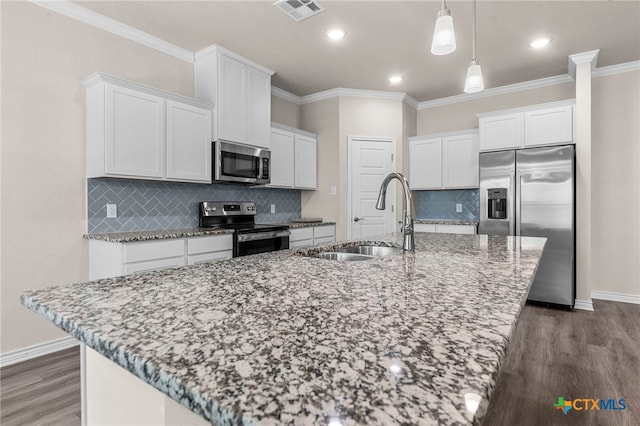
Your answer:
[83,222,336,243]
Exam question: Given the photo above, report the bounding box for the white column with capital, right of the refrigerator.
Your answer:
[569,50,599,310]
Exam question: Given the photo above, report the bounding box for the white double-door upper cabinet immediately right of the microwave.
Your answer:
[269,123,318,190]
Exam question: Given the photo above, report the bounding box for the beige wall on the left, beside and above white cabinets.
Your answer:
[0,2,193,353]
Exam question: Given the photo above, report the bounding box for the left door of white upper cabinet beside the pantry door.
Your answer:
[409,138,442,189]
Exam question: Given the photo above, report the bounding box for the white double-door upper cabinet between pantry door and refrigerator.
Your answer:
[409,129,479,189]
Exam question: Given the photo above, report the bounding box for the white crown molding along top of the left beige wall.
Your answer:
[31,0,195,64]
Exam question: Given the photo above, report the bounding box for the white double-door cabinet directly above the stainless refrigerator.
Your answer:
[478,100,575,151]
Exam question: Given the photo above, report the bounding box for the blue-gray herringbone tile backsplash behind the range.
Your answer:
[87,179,301,234]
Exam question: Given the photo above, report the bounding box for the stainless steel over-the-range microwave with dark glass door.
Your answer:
[212,141,271,185]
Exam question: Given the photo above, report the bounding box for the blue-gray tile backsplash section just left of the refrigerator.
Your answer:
[415,189,480,221]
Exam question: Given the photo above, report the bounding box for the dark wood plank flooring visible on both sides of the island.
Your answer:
[0,300,640,426]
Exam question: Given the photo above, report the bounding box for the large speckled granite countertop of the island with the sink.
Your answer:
[21,234,545,426]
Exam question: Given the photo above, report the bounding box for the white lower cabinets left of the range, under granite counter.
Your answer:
[89,234,233,280]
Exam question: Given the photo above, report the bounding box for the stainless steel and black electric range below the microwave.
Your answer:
[199,201,291,257]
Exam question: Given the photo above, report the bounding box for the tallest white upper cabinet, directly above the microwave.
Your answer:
[194,45,273,148]
